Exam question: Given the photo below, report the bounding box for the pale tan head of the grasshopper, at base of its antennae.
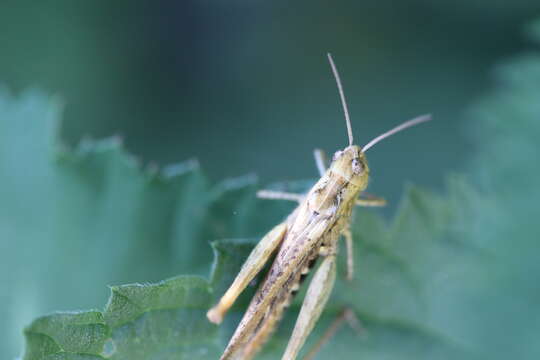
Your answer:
[330,145,369,191]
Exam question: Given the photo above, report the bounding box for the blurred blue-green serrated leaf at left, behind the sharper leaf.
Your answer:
[0,91,291,358]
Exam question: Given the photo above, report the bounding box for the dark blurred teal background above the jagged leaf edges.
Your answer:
[0,0,540,358]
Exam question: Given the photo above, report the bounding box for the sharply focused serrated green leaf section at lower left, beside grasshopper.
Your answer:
[25,276,218,359]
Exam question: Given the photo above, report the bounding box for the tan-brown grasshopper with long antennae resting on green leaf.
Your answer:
[207,54,431,360]
